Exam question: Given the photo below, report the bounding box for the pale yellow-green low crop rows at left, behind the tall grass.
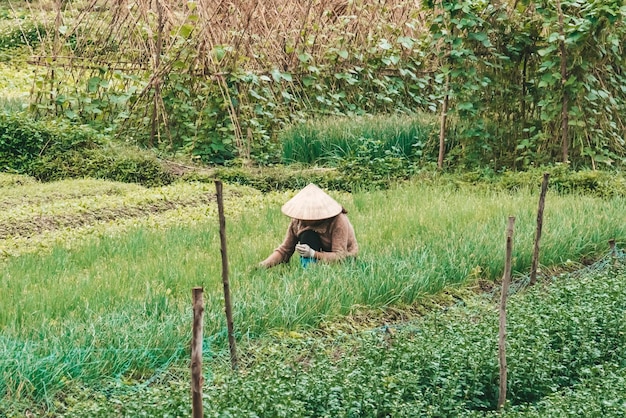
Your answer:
[0,174,288,258]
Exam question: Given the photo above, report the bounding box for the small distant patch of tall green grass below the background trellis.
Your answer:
[280,114,435,164]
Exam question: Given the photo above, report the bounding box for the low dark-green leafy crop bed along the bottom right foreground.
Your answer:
[0,253,626,418]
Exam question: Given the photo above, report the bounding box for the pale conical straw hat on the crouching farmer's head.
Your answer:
[282,183,343,221]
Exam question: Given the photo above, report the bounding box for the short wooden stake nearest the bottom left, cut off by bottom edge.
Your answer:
[191,287,204,418]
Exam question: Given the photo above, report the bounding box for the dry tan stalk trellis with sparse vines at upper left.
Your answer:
[18,0,423,162]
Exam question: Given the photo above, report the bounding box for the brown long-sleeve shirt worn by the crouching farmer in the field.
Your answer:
[261,213,359,267]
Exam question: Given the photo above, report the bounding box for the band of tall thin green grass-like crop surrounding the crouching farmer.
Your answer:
[0,180,626,400]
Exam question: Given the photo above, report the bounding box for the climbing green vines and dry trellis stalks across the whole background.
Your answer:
[15,0,626,170]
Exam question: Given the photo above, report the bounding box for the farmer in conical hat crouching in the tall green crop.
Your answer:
[260,183,359,267]
